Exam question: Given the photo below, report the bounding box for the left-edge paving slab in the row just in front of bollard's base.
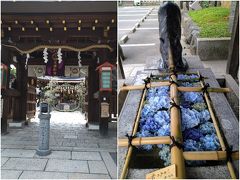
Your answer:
[2,158,47,171]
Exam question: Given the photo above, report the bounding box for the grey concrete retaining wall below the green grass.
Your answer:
[197,38,231,61]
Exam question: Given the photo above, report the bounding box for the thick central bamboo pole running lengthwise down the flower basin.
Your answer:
[169,49,185,179]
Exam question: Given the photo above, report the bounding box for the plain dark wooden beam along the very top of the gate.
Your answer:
[1,1,117,14]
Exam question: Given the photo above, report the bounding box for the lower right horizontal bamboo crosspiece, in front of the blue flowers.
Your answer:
[183,151,239,161]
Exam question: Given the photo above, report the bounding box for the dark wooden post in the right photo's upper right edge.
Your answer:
[226,2,239,79]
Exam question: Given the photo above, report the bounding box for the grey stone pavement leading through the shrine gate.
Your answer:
[1,109,117,179]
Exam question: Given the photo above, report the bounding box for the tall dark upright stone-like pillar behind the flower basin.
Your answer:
[158,2,188,71]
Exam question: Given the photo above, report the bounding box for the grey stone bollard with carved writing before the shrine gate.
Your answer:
[36,103,51,156]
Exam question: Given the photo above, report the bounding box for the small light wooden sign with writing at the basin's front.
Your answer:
[146,164,176,179]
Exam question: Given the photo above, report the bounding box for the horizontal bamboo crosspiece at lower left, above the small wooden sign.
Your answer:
[118,136,171,147]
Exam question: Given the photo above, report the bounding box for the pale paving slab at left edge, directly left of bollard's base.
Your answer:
[2,149,36,158]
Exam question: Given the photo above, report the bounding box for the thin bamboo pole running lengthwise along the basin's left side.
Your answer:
[120,89,147,179]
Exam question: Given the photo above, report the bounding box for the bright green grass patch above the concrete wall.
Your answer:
[188,7,230,38]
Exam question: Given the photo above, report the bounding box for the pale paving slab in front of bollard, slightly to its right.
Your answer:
[46,159,89,173]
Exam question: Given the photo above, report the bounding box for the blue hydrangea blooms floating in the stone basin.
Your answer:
[137,74,220,166]
